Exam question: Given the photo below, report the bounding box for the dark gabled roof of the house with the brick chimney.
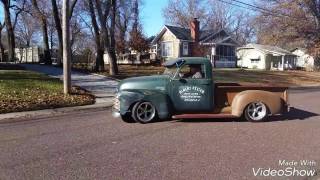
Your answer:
[152,25,237,44]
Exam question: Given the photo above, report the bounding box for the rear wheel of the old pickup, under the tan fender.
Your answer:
[244,102,268,122]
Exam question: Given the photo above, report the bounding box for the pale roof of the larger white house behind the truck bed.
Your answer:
[238,44,294,55]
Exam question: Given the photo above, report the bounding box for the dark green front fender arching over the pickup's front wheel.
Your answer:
[119,90,170,119]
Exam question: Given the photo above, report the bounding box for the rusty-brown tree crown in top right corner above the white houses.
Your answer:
[255,0,320,48]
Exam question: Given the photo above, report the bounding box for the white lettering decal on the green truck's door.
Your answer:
[179,86,205,102]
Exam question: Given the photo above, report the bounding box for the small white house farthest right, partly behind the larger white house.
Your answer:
[291,48,314,71]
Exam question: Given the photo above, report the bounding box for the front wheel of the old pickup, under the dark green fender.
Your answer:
[132,101,157,124]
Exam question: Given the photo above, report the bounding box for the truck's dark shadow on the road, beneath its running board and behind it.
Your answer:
[167,107,319,123]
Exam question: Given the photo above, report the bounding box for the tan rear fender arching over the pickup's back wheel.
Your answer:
[231,90,283,117]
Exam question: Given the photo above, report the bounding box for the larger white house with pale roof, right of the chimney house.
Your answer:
[237,44,296,70]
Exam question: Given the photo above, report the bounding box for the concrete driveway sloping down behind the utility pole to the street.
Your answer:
[21,64,118,103]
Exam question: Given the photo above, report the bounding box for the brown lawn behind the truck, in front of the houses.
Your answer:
[101,65,320,86]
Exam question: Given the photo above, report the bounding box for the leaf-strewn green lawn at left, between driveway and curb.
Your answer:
[0,65,94,113]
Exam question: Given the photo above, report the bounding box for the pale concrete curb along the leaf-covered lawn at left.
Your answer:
[0,102,113,123]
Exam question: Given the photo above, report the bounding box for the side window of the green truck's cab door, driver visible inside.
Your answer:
[179,64,205,79]
